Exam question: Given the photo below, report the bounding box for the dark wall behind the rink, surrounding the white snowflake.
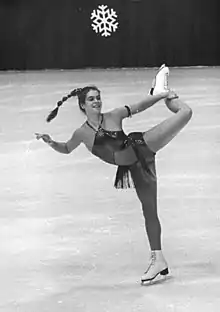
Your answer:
[0,0,220,70]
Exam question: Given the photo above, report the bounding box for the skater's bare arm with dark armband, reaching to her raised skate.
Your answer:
[112,92,169,119]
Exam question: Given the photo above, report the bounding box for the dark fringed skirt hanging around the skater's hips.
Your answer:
[114,132,157,190]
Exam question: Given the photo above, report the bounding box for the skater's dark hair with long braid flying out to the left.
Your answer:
[47,86,100,122]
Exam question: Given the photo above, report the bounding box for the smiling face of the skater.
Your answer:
[83,90,102,114]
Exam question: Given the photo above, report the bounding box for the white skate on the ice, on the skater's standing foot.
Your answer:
[141,250,169,285]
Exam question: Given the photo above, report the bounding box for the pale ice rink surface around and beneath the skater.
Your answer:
[0,67,220,312]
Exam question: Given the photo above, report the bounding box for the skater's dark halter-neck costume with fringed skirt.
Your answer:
[86,115,156,188]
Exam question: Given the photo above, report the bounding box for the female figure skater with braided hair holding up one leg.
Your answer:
[36,65,192,283]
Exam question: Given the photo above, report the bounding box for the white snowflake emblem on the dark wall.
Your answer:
[91,5,118,37]
